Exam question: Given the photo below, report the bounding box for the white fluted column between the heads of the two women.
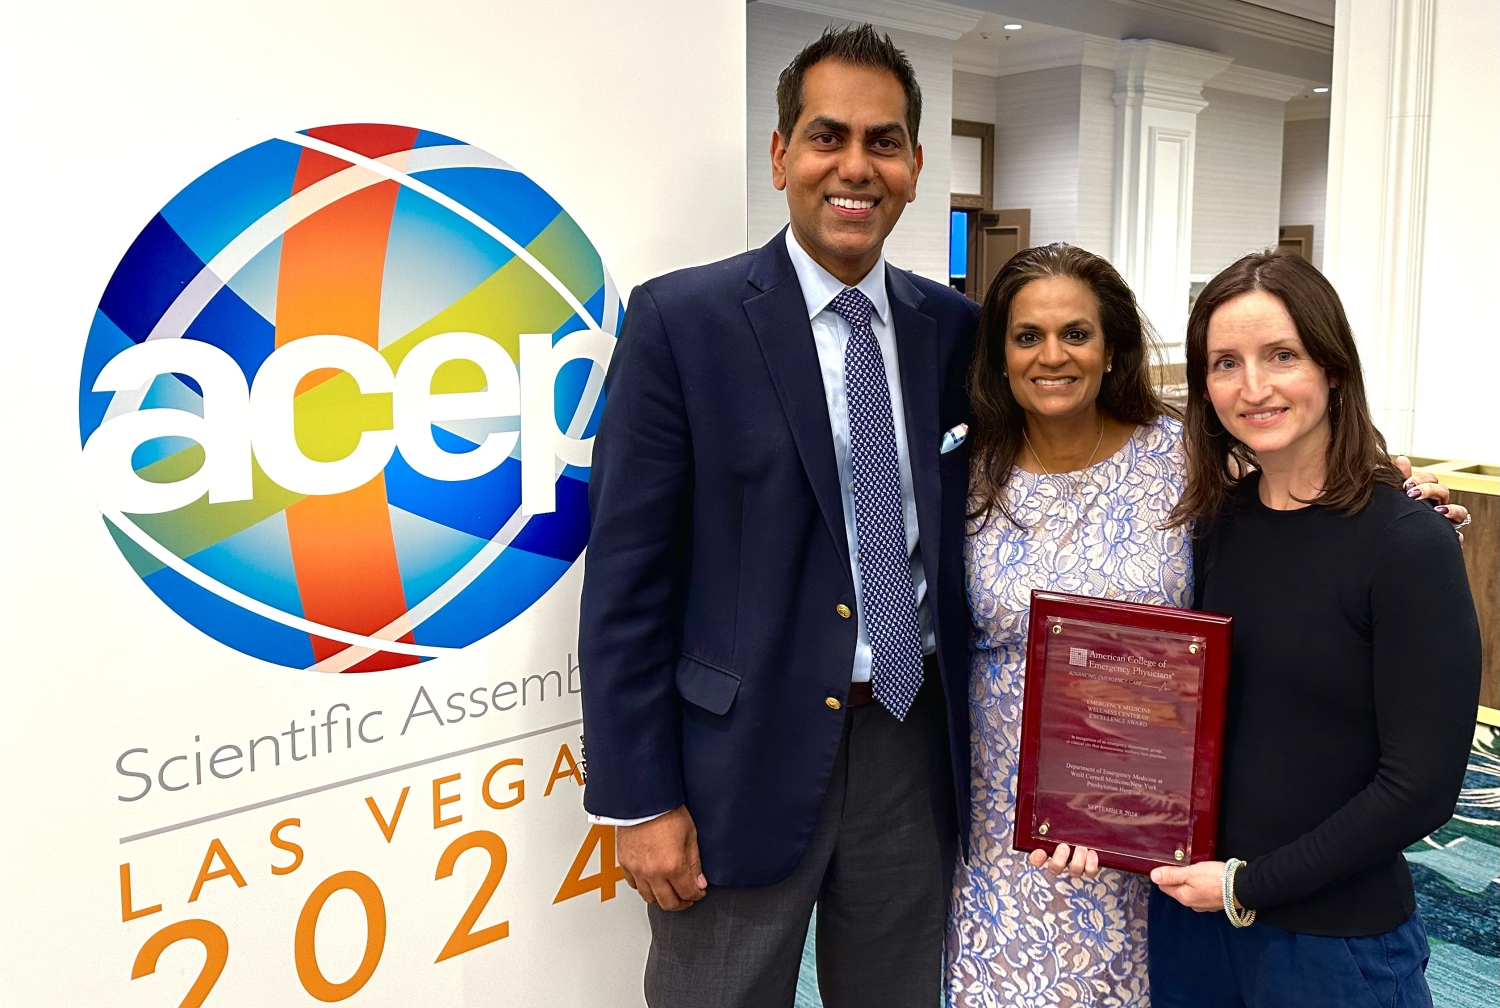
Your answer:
[1113,39,1232,362]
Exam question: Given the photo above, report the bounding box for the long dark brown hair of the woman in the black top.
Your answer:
[1169,249,1401,525]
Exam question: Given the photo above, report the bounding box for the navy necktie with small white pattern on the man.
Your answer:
[831,287,923,720]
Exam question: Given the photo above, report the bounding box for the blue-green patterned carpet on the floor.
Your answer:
[797,725,1500,1008]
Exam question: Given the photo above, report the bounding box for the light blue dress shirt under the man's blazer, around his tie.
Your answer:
[786,228,938,683]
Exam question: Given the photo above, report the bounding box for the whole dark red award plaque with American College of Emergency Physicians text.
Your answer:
[1013,591,1230,873]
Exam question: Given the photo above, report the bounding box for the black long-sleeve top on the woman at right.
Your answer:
[1196,474,1481,938]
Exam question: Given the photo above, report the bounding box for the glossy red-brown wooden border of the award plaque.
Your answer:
[1011,591,1232,873]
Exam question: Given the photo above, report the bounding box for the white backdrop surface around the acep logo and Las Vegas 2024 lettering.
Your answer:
[0,0,747,1008]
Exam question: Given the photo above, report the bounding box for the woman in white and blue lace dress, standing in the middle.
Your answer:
[948,245,1191,1008]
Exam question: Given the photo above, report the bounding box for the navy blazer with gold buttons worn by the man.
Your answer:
[579,233,978,885]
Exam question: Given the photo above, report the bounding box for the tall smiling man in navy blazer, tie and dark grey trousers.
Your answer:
[579,26,977,1008]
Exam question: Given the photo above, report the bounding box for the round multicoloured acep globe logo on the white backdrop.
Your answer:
[80,125,621,672]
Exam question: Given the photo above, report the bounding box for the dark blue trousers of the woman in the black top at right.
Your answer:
[1148,887,1433,1008]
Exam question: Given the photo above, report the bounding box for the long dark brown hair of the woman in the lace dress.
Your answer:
[969,242,1178,522]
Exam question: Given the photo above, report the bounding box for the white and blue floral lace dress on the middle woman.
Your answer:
[948,417,1193,1008]
